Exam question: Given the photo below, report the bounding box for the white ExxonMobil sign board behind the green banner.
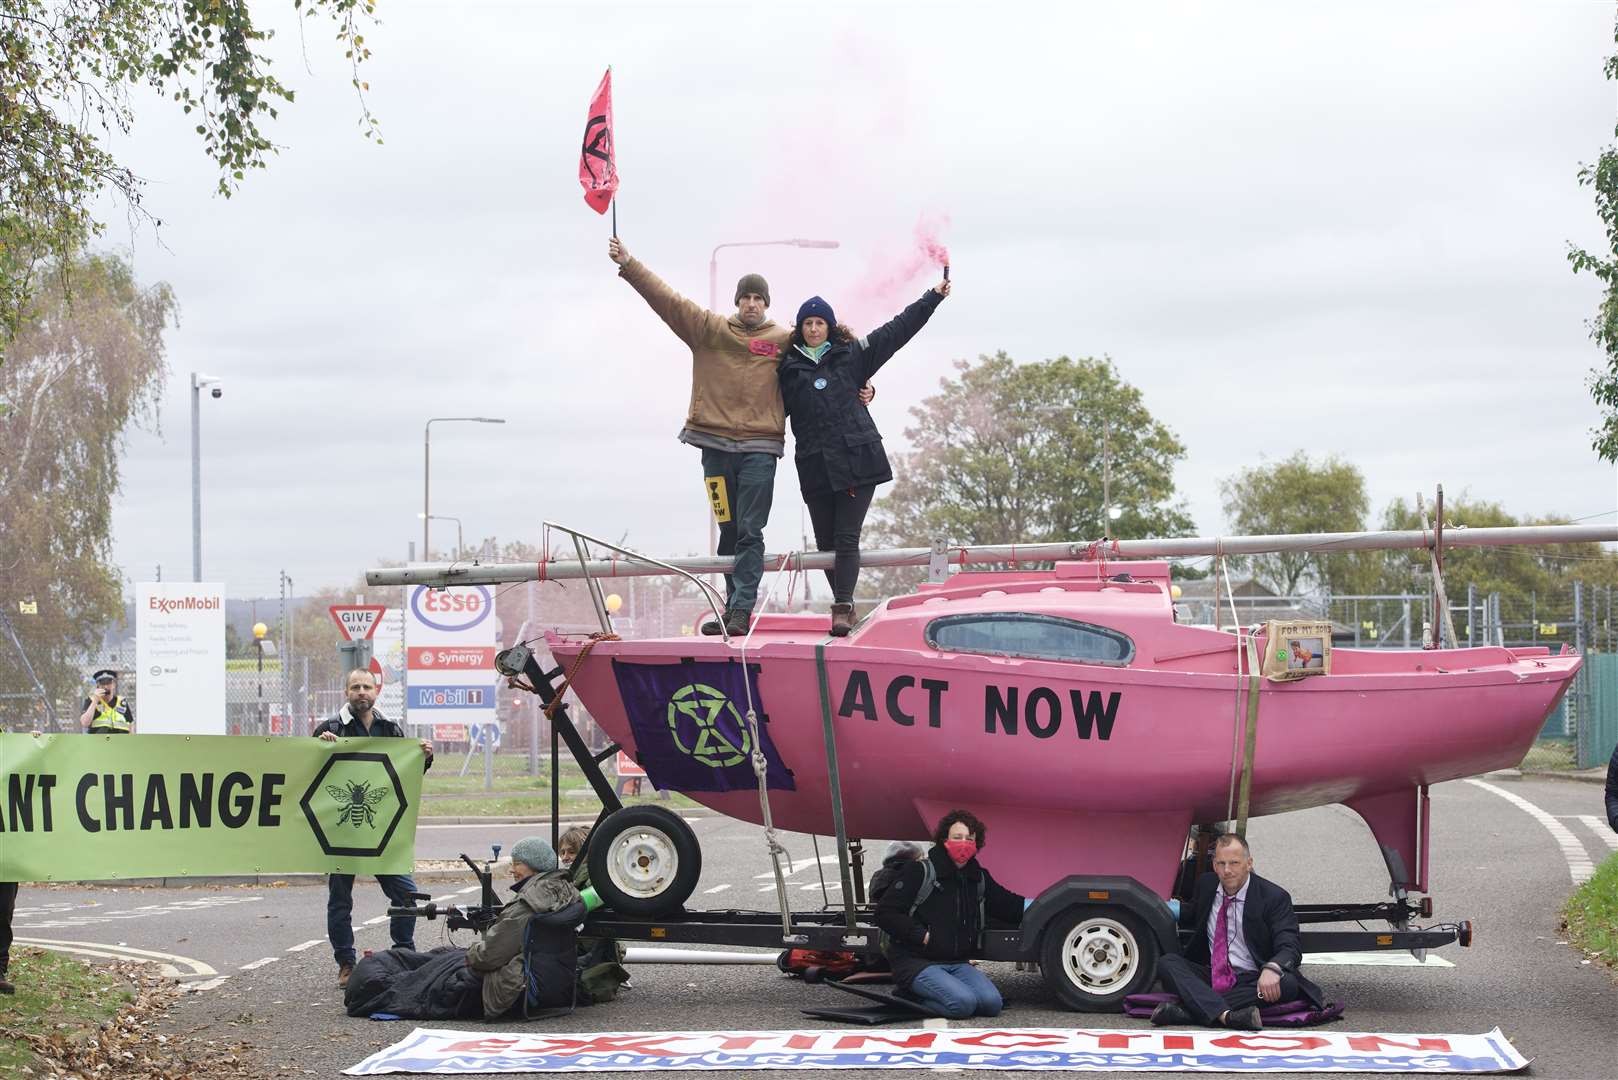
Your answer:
[134,581,227,735]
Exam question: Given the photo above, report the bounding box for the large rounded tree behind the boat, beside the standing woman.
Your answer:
[877,351,1191,546]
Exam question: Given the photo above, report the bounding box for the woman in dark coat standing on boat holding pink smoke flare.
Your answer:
[780,282,950,636]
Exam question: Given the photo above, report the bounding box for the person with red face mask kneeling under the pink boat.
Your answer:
[877,810,1026,1020]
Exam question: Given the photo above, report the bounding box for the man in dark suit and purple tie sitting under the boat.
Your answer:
[1152,832,1324,1031]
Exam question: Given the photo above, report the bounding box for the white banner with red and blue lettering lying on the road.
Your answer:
[345,1028,1529,1077]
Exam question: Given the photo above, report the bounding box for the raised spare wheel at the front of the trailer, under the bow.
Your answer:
[587,806,702,918]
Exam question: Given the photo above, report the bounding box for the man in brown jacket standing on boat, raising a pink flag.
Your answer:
[607,236,874,635]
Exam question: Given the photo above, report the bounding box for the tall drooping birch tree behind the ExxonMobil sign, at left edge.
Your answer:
[0,256,175,719]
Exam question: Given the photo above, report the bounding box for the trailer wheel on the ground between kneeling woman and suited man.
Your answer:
[1040,907,1157,1012]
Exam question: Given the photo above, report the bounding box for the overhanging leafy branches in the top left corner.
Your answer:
[0,0,380,347]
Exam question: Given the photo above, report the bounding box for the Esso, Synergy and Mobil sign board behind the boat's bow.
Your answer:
[405,585,498,724]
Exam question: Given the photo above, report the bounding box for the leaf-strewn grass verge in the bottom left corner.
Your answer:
[0,949,134,1077]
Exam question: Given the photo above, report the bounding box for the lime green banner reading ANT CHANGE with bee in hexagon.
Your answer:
[0,735,422,881]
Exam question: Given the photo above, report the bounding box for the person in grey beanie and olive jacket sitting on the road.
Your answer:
[466,836,584,1020]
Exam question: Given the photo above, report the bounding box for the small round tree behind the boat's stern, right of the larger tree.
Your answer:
[1220,450,1370,596]
